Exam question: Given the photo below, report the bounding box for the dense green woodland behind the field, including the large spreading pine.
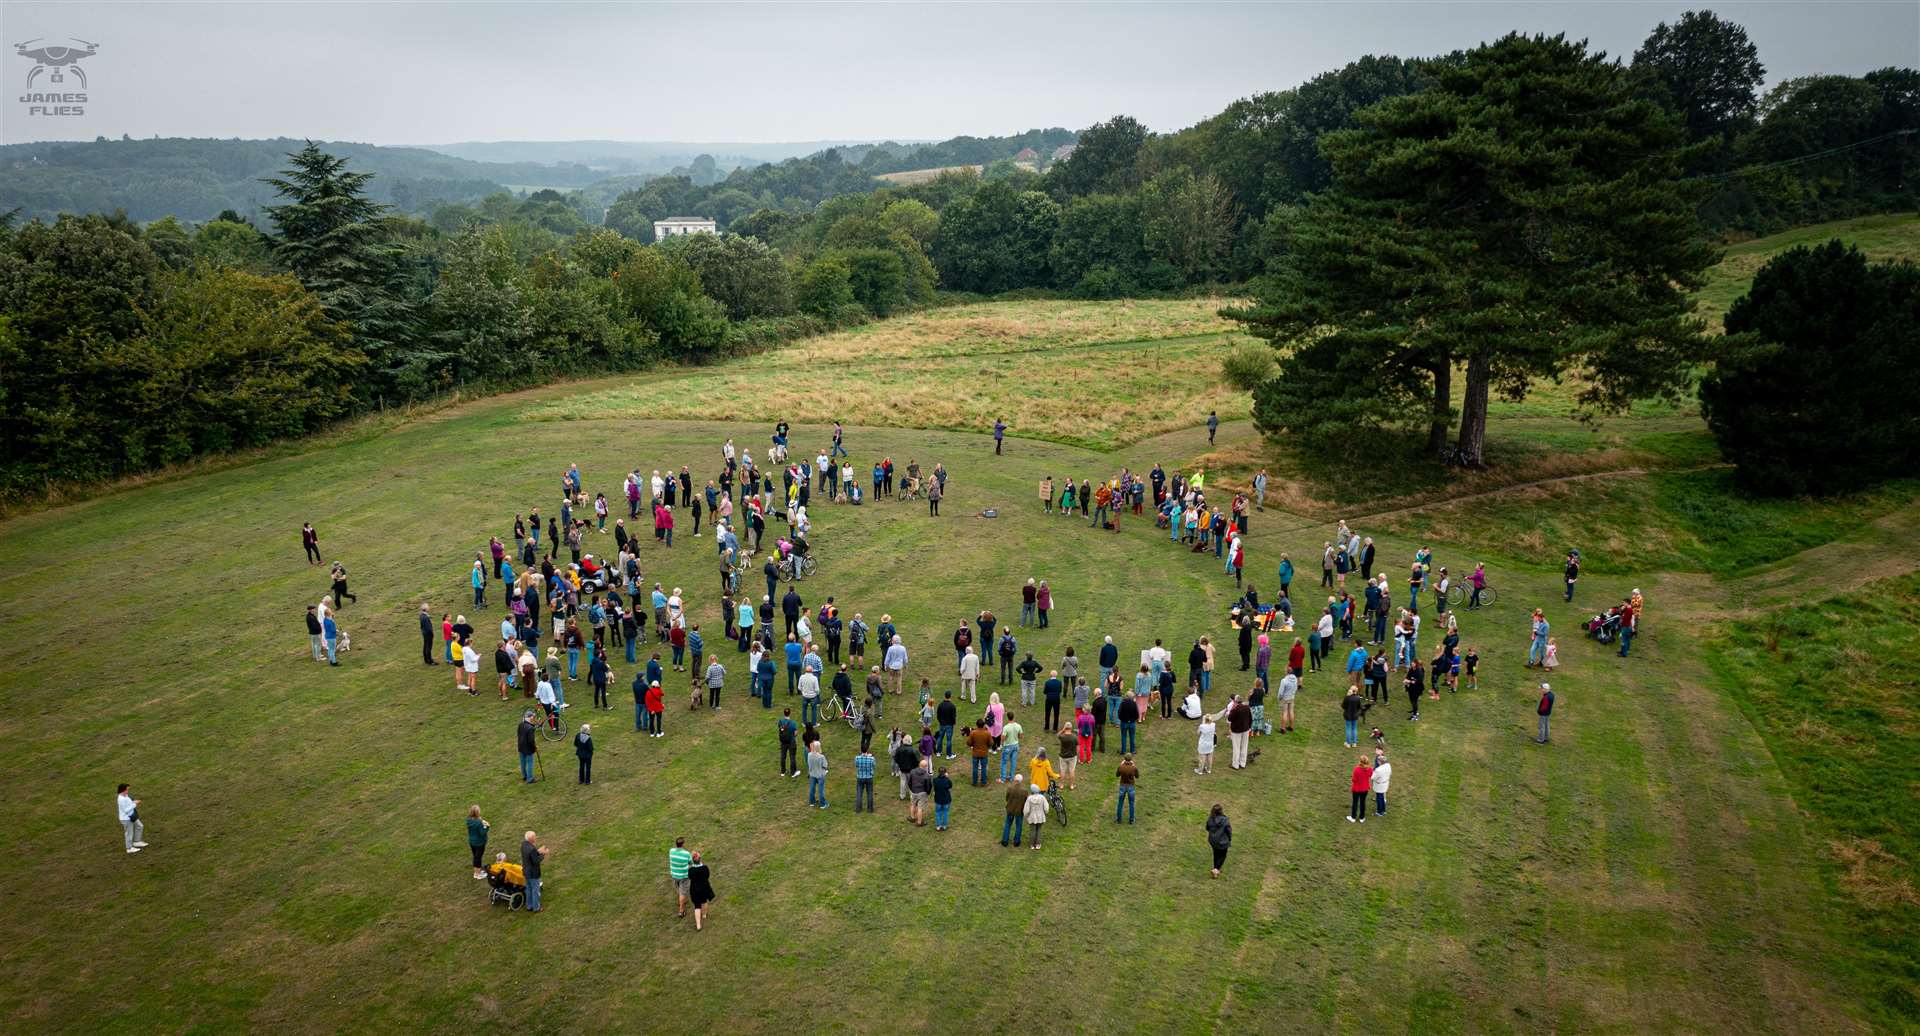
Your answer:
[0,13,1920,495]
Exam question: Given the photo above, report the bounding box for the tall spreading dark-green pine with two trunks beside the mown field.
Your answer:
[1231,35,1716,466]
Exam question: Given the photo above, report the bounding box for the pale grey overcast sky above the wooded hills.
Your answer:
[0,0,1920,144]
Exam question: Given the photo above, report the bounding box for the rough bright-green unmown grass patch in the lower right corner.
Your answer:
[1709,576,1920,1028]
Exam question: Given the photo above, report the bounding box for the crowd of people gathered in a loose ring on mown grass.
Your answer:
[263,422,1644,927]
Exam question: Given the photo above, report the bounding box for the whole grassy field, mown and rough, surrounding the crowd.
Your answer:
[0,236,1920,1032]
